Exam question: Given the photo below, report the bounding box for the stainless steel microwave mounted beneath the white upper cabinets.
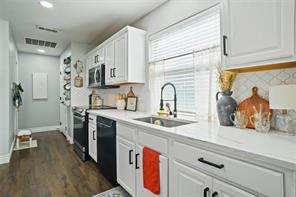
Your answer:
[88,64,105,87]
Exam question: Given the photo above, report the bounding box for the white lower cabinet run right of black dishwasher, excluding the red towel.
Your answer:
[117,123,295,197]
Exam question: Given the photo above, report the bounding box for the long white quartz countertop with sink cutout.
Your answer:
[88,110,296,170]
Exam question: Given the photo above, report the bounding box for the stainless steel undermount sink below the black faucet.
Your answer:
[134,116,194,128]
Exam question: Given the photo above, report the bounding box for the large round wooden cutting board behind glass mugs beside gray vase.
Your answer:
[238,87,272,129]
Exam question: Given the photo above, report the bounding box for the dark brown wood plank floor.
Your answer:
[0,131,112,197]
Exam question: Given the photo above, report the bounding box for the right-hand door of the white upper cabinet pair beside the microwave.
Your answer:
[114,32,128,83]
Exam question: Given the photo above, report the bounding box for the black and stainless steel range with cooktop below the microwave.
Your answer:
[73,105,115,161]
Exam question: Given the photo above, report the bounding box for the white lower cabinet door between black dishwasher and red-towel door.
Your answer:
[116,137,136,196]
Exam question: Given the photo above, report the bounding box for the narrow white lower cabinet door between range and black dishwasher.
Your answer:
[88,124,97,162]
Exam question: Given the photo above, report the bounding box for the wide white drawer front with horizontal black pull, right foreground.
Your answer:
[173,142,284,197]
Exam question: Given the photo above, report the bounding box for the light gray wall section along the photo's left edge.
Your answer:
[0,19,18,156]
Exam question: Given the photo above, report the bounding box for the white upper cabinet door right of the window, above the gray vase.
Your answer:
[221,0,295,69]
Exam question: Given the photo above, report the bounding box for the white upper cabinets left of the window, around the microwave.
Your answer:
[88,26,146,85]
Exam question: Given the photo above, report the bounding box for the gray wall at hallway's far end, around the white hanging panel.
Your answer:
[19,53,60,129]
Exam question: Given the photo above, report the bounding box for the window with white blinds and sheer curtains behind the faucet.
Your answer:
[149,8,220,119]
